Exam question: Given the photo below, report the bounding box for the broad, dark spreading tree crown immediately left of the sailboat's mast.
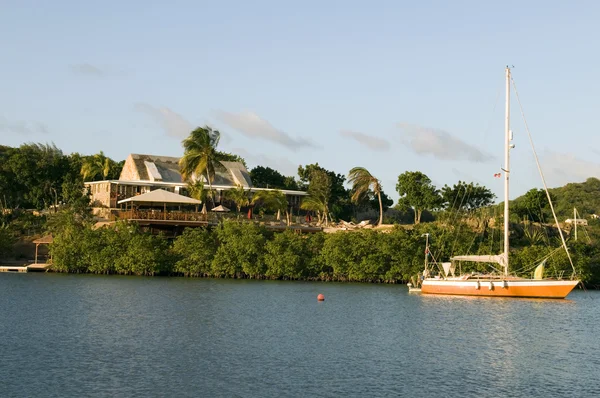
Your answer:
[441,181,496,210]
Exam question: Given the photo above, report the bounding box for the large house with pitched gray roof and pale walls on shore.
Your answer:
[84,153,307,209]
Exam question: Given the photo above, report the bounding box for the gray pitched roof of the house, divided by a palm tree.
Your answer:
[122,153,252,188]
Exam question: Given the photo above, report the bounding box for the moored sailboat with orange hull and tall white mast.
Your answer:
[420,66,580,299]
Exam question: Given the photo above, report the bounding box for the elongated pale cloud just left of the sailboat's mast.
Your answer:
[398,123,494,163]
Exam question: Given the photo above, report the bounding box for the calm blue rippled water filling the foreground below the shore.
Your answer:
[0,274,600,397]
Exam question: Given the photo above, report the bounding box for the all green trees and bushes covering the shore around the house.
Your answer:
[0,137,600,285]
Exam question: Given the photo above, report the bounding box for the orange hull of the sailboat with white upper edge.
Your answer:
[421,279,579,299]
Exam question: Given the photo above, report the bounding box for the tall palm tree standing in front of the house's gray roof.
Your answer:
[179,126,223,206]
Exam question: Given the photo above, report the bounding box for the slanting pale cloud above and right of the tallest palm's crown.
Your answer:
[215,111,315,150]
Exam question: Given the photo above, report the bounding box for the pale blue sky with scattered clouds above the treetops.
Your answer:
[0,0,600,201]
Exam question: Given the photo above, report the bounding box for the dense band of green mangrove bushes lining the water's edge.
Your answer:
[51,216,600,283]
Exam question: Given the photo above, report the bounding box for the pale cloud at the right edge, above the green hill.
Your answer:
[541,152,600,186]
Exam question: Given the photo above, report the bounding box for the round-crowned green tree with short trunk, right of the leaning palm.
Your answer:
[396,171,441,224]
